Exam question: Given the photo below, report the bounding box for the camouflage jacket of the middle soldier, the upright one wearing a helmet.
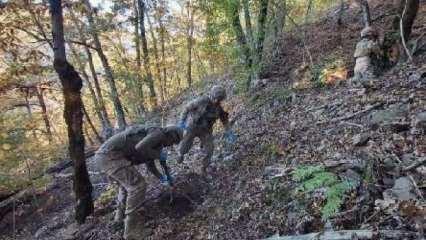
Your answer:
[181,96,229,131]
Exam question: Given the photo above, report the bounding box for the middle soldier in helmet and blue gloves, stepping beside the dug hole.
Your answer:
[178,86,236,175]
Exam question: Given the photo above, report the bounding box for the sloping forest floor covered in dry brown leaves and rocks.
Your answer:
[0,0,426,240]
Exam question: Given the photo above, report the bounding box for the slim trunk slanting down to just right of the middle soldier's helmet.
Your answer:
[230,1,253,90]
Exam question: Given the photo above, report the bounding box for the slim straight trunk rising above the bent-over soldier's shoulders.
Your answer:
[137,0,157,107]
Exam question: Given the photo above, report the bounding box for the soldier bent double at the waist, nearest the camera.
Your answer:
[95,125,183,240]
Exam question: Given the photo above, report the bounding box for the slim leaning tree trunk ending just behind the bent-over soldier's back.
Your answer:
[84,0,126,130]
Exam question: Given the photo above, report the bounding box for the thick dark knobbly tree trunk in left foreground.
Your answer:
[49,0,94,224]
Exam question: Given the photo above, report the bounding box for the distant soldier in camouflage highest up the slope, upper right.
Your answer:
[352,26,381,85]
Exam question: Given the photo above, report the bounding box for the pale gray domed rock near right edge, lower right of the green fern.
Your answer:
[383,177,417,201]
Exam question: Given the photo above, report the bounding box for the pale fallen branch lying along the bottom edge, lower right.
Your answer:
[268,230,417,240]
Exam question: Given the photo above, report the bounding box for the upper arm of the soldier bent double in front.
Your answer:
[135,130,166,159]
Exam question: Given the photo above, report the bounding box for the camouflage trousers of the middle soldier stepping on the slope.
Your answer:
[179,129,214,174]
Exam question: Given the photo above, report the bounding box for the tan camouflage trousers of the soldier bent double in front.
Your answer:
[95,153,146,240]
